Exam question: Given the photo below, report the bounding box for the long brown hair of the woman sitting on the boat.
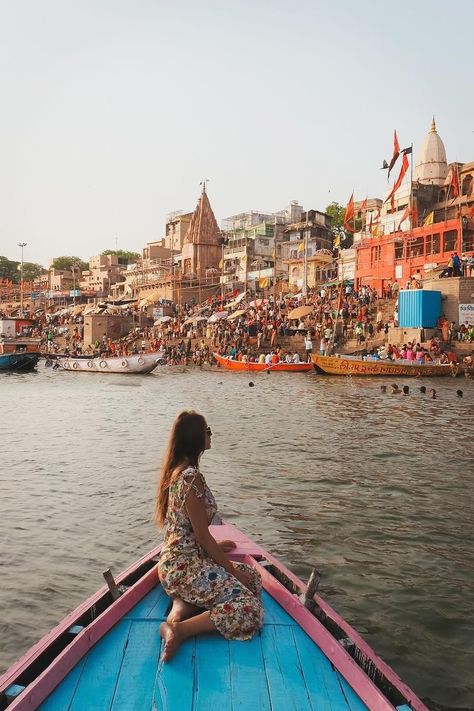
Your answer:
[155,410,206,526]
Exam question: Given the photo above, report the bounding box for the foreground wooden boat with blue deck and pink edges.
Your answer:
[0,525,427,711]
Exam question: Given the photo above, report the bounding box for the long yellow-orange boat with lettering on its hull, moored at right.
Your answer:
[311,354,457,378]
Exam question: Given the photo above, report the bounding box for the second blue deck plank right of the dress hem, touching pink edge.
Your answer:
[292,627,360,711]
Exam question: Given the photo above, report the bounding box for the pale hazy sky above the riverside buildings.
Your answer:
[0,0,474,264]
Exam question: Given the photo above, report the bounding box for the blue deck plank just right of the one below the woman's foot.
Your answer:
[193,635,232,711]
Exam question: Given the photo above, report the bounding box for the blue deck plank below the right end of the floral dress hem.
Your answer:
[229,636,271,711]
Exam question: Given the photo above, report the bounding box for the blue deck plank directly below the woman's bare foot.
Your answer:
[153,639,196,711]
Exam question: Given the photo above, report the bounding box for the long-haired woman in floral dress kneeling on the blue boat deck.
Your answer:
[155,412,263,662]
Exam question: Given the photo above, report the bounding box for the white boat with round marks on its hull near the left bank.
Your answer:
[55,351,165,375]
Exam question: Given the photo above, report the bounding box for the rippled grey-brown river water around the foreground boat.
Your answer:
[0,363,474,708]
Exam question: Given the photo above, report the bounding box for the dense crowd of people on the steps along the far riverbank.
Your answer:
[0,282,474,365]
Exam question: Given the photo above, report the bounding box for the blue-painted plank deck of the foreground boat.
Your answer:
[39,587,367,711]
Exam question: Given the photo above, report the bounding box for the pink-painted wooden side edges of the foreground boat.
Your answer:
[0,524,427,711]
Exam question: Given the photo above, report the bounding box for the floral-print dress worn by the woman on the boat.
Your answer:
[158,466,263,640]
